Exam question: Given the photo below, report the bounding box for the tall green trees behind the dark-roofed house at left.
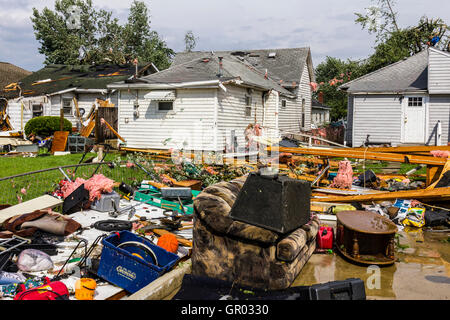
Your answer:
[31,0,174,69]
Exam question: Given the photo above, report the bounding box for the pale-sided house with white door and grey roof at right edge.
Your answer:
[340,47,450,147]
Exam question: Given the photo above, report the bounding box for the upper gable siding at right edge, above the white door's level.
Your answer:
[428,49,450,94]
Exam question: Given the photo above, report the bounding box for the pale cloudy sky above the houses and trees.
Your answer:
[0,0,450,71]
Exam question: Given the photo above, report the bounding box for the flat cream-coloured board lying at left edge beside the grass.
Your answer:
[0,195,63,224]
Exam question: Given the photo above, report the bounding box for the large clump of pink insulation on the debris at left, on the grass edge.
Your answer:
[61,174,114,201]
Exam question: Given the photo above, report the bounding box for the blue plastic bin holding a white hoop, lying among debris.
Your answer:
[97,231,179,293]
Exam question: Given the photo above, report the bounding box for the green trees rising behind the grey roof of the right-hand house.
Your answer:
[315,0,450,120]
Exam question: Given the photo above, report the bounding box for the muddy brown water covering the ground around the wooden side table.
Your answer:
[292,228,450,300]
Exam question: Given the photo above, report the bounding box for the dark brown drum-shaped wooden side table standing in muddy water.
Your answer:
[336,211,397,265]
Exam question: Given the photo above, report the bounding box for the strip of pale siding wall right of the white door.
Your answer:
[427,95,450,145]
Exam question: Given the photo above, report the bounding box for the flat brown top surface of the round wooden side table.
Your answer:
[336,211,397,234]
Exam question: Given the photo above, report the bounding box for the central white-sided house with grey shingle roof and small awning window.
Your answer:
[108,48,315,151]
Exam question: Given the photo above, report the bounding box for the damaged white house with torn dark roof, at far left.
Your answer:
[5,64,158,130]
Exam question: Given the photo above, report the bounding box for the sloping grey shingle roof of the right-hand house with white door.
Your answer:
[339,50,428,93]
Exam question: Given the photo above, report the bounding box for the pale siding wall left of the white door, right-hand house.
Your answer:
[353,95,402,147]
